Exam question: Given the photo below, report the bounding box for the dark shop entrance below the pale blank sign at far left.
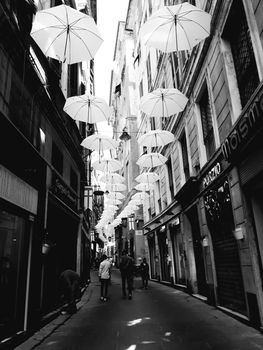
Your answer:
[0,202,29,339]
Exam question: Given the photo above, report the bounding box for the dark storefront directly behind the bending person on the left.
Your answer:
[41,173,81,314]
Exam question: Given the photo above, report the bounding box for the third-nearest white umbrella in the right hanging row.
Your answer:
[138,129,175,147]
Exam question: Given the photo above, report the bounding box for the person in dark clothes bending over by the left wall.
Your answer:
[60,269,81,314]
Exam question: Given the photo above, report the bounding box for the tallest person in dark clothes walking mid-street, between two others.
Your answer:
[120,251,134,299]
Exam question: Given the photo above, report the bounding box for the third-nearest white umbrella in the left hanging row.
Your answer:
[80,134,118,152]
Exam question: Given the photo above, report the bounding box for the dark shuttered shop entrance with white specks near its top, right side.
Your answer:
[204,180,246,314]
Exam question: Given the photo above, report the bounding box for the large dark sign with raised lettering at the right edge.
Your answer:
[221,85,263,161]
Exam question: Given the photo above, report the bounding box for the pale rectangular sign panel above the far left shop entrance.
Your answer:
[0,165,38,214]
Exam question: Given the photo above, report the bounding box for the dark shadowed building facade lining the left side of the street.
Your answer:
[0,0,96,346]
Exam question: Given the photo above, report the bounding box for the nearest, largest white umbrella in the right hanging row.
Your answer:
[141,2,211,52]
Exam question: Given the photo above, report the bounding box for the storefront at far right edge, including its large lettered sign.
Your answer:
[222,84,263,325]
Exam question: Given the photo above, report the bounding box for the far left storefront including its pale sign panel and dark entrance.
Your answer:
[0,165,38,339]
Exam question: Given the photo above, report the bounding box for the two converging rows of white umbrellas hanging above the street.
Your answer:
[31,2,211,231]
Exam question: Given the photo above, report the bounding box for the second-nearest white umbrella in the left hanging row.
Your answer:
[63,94,111,124]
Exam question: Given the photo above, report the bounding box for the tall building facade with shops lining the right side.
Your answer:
[112,0,263,327]
